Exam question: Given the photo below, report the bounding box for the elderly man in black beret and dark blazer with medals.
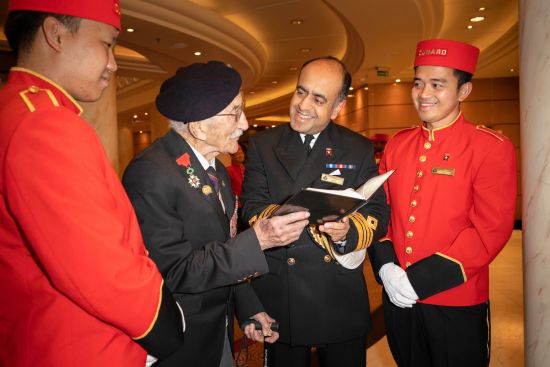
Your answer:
[123,61,308,367]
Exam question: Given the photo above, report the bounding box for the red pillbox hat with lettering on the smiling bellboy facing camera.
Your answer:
[414,39,479,74]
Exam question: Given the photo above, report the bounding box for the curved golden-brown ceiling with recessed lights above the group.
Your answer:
[0,0,519,123]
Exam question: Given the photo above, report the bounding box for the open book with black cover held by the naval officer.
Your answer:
[273,170,394,224]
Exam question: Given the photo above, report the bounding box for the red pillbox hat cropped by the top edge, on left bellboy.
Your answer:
[8,0,120,30]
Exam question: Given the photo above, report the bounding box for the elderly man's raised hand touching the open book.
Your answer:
[252,211,309,250]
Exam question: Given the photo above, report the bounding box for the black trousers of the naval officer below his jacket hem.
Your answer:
[265,336,367,367]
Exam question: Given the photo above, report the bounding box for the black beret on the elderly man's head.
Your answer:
[156,61,241,122]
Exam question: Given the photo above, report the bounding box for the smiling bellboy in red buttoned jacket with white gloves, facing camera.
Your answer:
[374,40,516,367]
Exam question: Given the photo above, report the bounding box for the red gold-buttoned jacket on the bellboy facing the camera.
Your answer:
[375,114,517,306]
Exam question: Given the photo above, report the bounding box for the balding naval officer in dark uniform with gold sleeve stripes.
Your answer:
[241,57,389,367]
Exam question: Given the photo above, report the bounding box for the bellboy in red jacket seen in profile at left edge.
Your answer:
[0,0,187,367]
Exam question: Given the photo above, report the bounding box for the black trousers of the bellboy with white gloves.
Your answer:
[383,292,491,367]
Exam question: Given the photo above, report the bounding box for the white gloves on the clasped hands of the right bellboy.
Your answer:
[378,263,418,308]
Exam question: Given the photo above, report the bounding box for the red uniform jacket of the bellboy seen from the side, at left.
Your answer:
[0,68,182,367]
